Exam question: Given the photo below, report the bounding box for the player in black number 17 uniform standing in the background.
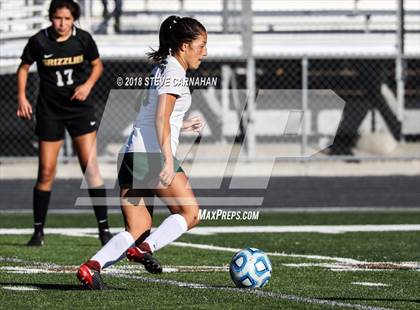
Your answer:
[17,0,112,246]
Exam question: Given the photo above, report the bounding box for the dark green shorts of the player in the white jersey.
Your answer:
[117,152,184,189]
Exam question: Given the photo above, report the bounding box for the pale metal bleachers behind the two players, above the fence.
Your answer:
[0,0,420,73]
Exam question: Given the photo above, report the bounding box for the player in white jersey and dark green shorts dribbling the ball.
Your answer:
[77,16,207,289]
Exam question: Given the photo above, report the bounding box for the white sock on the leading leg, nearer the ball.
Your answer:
[144,214,188,252]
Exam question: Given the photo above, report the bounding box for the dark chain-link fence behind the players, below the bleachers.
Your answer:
[0,57,420,158]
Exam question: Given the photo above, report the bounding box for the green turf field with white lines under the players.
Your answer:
[0,212,420,309]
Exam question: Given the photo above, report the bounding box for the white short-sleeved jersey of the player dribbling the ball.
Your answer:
[122,56,191,155]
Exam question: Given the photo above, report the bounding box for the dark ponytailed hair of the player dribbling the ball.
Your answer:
[147,15,206,62]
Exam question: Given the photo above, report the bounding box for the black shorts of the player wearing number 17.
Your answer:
[35,113,98,141]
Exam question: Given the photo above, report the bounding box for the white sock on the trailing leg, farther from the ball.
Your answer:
[91,231,134,268]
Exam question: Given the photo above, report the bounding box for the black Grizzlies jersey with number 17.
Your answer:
[21,27,99,119]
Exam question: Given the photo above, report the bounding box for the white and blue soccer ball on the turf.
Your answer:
[229,248,273,288]
